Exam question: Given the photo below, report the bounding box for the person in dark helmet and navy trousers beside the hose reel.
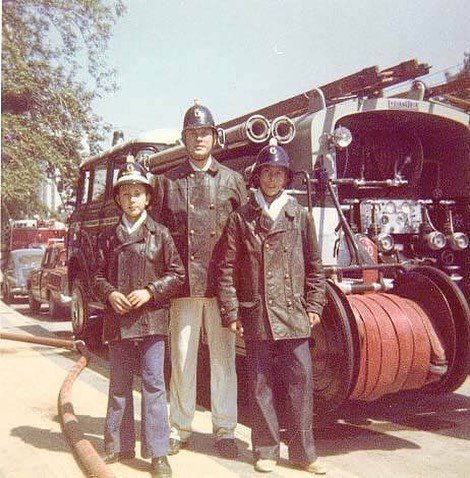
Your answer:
[218,144,325,474]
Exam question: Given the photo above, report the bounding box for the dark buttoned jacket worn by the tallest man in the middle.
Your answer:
[152,158,247,297]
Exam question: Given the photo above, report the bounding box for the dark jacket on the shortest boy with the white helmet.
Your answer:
[92,216,185,342]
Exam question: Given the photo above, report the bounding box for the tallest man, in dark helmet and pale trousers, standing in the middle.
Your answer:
[154,103,247,458]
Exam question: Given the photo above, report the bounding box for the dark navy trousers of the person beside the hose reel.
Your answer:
[246,339,317,464]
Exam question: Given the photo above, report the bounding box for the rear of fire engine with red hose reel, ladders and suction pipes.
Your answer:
[145,60,470,409]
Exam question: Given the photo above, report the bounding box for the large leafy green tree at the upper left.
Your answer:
[2,0,125,217]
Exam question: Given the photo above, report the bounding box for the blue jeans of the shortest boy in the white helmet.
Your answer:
[104,335,170,458]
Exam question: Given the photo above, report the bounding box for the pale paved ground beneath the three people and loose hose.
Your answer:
[0,302,470,478]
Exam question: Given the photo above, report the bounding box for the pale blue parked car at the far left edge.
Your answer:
[2,249,44,304]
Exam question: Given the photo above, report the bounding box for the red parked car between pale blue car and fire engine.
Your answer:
[27,241,71,318]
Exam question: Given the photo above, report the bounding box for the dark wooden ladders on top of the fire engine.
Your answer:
[220,59,470,129]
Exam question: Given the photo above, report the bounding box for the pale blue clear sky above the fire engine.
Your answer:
[94,0,470,139]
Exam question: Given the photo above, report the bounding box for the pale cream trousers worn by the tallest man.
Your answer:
[170,297,237,441]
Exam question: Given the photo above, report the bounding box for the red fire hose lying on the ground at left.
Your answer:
[0,331,115,478]
